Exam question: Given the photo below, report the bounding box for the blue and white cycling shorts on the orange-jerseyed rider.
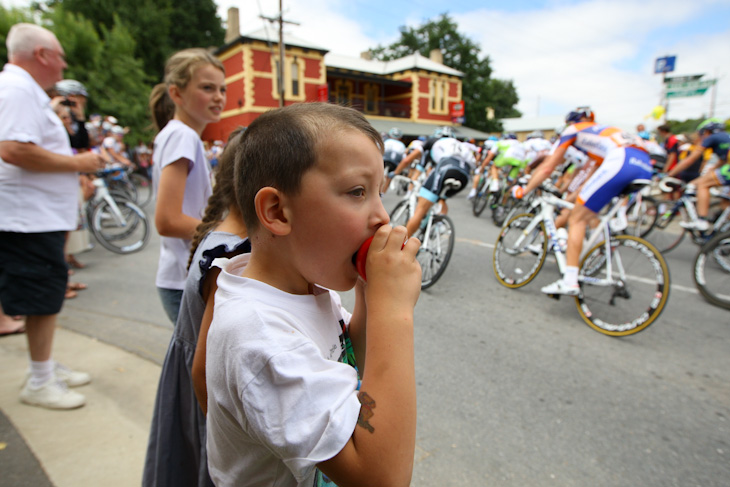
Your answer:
[578,147,652,213]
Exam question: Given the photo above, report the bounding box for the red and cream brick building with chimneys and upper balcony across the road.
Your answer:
[203,8,489,140]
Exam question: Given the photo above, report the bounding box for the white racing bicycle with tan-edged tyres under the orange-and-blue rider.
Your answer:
[493,180,670,336]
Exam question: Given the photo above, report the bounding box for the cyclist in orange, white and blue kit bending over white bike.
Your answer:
[524,107,652,296]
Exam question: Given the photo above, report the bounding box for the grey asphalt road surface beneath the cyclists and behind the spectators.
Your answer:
[61,194,730,487]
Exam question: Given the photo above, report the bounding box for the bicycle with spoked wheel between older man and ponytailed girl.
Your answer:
[85,167,150,254]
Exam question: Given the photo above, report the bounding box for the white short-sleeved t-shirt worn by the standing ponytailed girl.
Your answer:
[152,120,212,290]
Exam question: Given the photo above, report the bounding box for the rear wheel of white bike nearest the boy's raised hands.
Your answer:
[416,215,456,289]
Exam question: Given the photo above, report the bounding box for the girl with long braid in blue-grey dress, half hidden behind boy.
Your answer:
[142,130,251,487]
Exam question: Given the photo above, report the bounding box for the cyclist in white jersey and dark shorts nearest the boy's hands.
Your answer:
[398,131,476,237]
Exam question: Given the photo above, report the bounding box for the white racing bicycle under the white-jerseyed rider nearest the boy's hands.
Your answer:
[390,175,456,289]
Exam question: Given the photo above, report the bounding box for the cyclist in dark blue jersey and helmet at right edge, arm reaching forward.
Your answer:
[667,118,730,232]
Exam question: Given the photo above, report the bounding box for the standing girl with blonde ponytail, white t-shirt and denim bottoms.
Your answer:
[150,49,226,323]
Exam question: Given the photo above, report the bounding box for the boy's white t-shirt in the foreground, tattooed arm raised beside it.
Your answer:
[206,254,360,487]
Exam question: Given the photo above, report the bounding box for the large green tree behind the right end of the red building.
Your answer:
[370,13,521,132]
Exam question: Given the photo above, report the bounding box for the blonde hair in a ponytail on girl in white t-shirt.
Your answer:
[149,48,226,132]
